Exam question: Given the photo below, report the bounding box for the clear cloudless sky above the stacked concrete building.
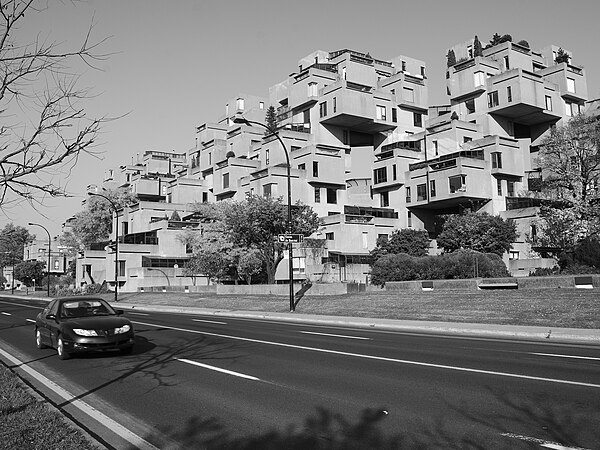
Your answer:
[0,0,600,237]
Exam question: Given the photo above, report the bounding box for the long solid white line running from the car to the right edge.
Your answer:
[134,322,600,389]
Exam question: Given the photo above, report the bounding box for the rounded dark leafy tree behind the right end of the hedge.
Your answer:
[437,212,517,256]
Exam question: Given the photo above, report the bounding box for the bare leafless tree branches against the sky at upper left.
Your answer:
[0,0,106,207]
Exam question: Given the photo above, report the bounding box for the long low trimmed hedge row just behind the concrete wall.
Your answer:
[371,250,510,286]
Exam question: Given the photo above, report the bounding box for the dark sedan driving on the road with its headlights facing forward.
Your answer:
[35,297,134,359]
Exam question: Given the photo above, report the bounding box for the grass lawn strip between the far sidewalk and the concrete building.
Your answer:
[112,289,600,329]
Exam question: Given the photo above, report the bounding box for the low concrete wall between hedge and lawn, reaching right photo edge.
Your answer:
[385,275,600,291]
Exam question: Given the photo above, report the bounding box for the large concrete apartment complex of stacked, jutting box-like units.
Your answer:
[75,41,587,290]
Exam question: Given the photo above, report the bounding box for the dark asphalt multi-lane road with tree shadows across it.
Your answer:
[0,298,600,449]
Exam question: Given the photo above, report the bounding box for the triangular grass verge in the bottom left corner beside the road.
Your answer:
[0,363,98,450]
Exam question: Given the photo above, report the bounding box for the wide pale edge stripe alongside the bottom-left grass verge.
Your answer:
[0,348,158,450]
